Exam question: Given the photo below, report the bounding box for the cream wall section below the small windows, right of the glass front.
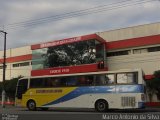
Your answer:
[107,51,160,75]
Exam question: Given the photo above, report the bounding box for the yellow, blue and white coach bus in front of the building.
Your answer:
[16,69,145,112]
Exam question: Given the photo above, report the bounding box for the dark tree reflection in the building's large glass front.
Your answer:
[42,40,96,67]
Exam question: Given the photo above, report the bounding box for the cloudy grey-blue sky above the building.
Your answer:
[0,0,160,50]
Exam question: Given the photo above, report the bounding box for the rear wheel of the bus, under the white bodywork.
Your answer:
[95,99,108,112]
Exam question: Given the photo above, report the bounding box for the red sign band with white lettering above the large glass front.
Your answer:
[31,34,105,50]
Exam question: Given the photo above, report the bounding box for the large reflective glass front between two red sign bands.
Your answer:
[32,39,99,70]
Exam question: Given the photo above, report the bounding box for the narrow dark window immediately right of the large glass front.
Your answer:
[107,50,130,57]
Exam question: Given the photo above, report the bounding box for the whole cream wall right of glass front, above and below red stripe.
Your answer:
[96,22,160,74]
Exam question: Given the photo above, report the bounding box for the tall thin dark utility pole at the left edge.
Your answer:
[0,30,7,108]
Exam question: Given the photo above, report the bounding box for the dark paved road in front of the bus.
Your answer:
[0,107,160,120]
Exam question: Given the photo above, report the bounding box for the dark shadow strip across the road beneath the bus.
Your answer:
[0,106,160,114]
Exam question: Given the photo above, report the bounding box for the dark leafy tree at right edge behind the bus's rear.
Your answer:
[146,70,160,101]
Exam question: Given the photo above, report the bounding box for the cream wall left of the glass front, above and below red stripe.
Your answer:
[0,46,32,81]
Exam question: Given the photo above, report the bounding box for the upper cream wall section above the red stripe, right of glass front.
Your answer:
[96,22,160,42]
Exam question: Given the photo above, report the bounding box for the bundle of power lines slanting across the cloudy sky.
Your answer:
[0,0,157,29]
